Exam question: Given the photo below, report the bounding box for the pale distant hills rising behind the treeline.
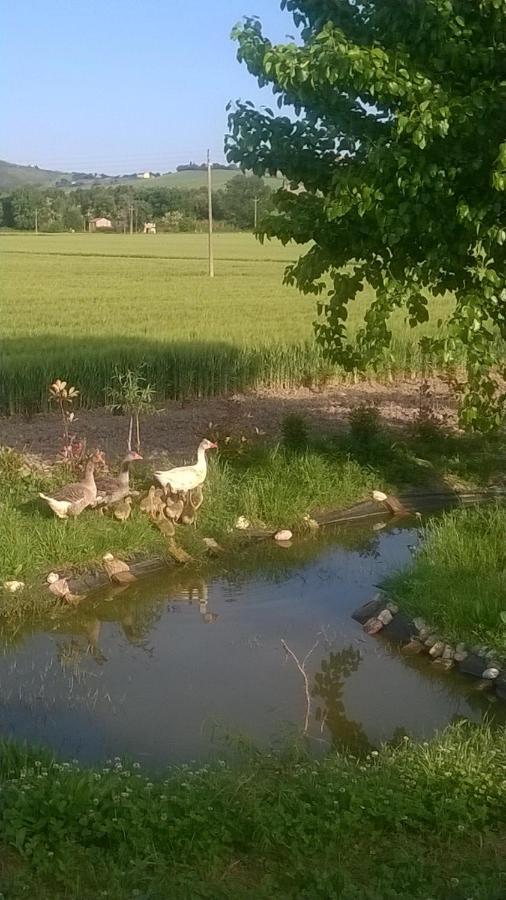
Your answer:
[0,160,281,190]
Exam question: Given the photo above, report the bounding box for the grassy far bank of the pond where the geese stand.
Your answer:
[0,438,374,596]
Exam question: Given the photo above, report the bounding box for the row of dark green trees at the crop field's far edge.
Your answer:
[0,175,273,232]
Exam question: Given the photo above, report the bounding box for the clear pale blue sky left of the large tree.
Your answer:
[0,0,294,174]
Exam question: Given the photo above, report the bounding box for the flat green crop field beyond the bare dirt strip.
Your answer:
[0,234,448,413]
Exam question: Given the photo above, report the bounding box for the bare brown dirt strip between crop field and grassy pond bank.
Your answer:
[0,380,455,460]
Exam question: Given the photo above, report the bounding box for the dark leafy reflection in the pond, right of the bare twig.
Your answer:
[311,645,371,752]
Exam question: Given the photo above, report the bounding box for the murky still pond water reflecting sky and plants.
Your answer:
[0,524,505,766]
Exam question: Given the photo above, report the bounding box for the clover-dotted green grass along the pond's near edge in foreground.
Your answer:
[0,725,506,900]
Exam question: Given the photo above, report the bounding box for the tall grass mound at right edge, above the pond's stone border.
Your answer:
[386,506,506,653]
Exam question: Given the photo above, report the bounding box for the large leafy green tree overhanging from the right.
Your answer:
[227,0,506,427]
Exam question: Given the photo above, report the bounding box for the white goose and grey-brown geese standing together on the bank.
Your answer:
[39,438,217,520]
